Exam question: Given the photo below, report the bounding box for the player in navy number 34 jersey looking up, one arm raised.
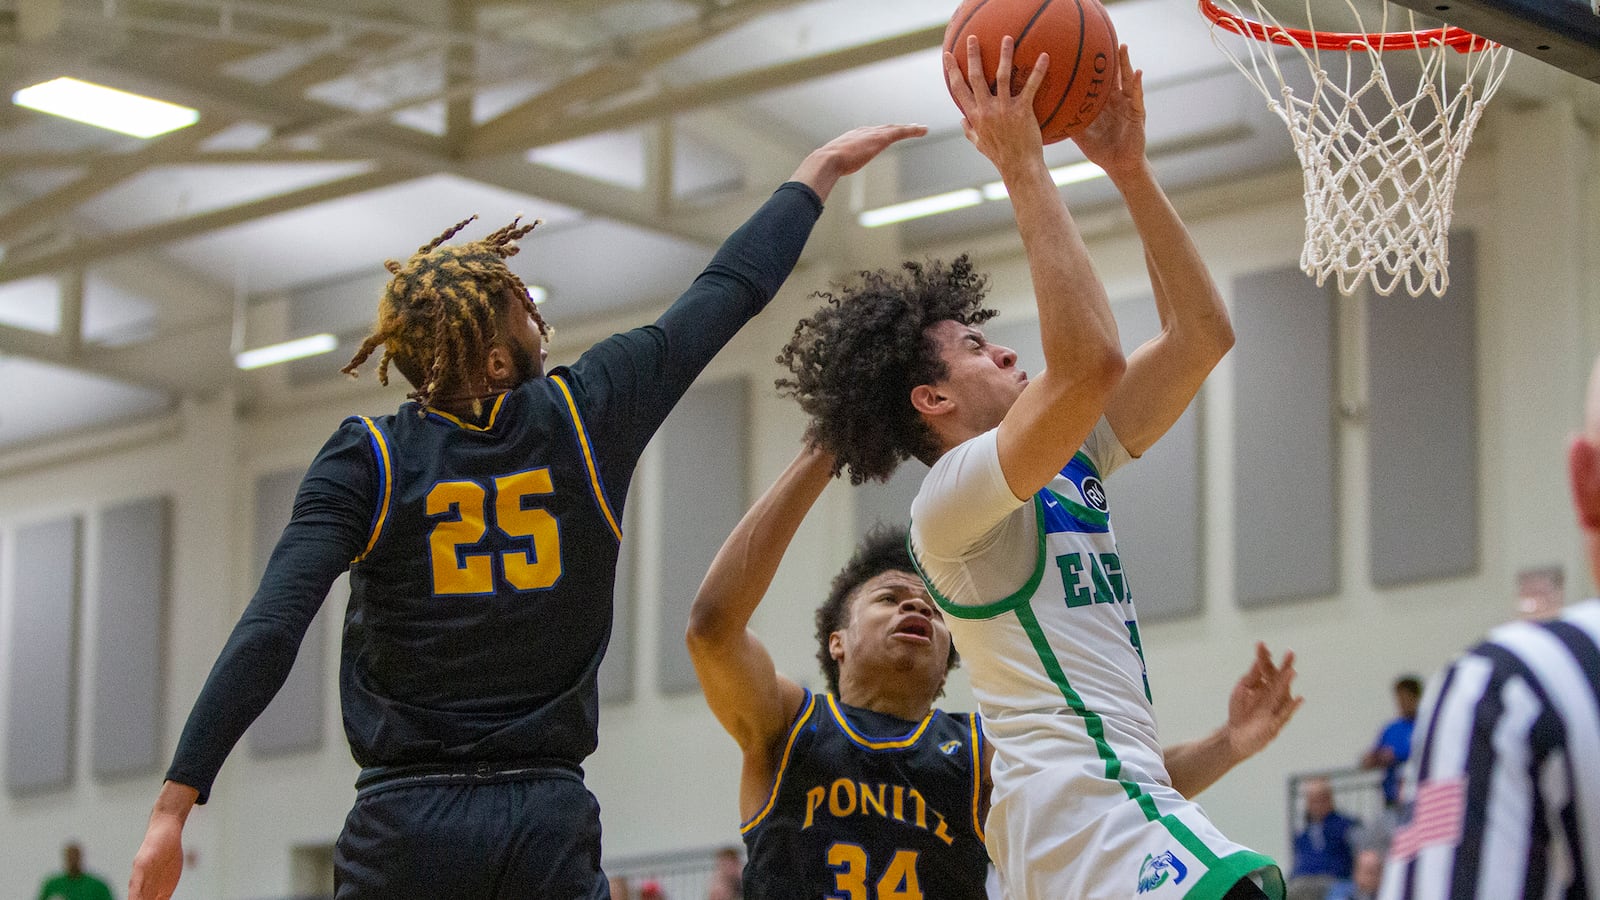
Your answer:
[688,447,989,900]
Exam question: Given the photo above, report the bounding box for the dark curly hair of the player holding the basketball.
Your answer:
[778,253,995,484]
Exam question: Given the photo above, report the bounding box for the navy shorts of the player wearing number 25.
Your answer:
[334,759,611,900]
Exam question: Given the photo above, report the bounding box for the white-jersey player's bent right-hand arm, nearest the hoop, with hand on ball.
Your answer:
[1077,45,1234,456]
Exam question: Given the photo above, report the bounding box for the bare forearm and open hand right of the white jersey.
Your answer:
[1165,644,1306,798]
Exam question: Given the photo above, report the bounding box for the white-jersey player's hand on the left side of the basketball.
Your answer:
[944,35,1050,173]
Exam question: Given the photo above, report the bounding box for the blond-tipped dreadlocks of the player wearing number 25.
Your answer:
[339,215,550,412]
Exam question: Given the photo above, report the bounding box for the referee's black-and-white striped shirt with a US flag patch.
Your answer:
[1379,599,1600,900]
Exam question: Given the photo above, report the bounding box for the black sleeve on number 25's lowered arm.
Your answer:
[166,424,378,802]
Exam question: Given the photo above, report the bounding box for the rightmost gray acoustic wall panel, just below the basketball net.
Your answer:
[1366,227,1478,586]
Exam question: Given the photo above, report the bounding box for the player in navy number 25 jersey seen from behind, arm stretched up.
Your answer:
[130,125,925,900]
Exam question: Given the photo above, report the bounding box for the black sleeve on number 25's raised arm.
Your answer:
[571,181,822,464]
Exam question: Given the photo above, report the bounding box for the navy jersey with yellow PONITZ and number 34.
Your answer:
[741,692,989,900]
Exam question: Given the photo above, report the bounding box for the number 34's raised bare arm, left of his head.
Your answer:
[686,447,834,790]
